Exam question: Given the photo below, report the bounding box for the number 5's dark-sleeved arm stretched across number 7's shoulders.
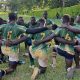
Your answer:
[18,25,57,34]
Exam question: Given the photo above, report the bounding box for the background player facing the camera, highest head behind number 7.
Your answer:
[42,11,56,69]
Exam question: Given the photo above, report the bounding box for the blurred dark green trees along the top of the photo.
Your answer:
[0,0,80,12]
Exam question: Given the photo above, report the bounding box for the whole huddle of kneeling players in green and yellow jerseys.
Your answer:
[0,11,80,80]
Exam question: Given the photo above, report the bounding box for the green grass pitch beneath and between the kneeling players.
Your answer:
[0,15,80,80]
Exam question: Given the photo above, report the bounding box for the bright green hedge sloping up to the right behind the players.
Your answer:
[28,5,80,18]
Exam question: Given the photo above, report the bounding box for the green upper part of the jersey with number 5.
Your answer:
[0,23,26,51]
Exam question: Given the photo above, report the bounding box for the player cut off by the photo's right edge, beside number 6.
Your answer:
[63,15,80,69]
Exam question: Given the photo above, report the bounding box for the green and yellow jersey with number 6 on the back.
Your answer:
[56,29,76,55]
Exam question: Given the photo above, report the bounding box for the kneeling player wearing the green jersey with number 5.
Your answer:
[0,13,26,79]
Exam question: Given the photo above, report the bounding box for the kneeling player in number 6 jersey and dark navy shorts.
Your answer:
[33,15,76,78]
